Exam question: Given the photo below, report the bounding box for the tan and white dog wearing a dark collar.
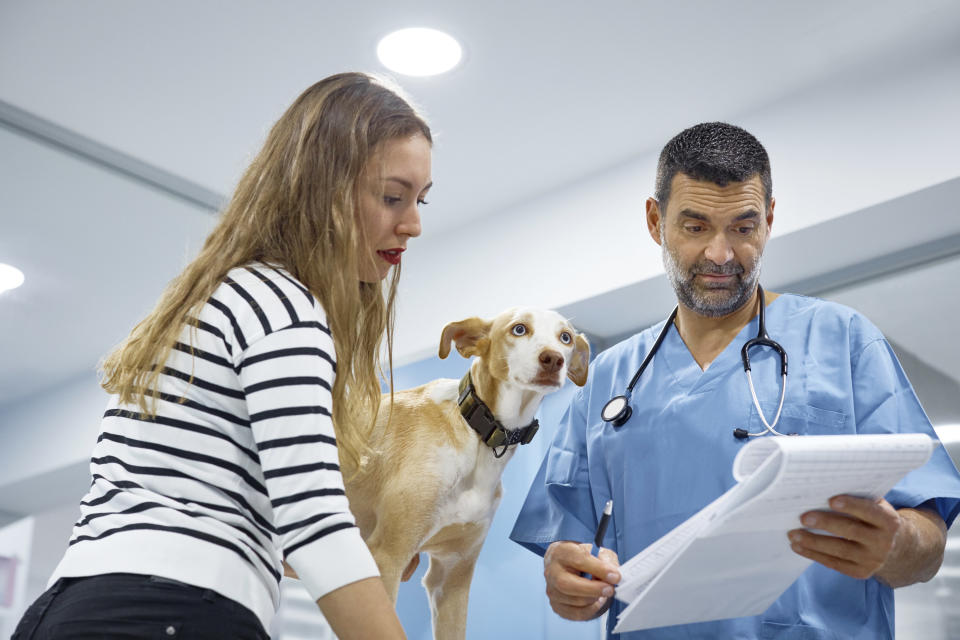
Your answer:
[347,308,590,640]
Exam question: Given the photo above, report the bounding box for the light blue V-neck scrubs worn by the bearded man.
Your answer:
[510,295,960,640]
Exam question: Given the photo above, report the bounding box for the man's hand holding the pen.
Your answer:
[543,541,620,620]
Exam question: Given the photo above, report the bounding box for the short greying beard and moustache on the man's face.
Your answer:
[660,238,761,318]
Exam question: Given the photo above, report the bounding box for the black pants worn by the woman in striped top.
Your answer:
[11,573,269,640]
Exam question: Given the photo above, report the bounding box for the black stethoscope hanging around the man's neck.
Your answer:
[600,285,794,440]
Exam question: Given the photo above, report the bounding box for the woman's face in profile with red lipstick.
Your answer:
[357,134,433,282]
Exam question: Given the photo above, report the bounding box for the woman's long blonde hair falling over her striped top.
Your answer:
[101,73,432,467]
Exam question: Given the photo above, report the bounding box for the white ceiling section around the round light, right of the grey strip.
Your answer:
[0,0,960,231]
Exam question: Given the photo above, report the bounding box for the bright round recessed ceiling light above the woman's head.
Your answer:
[377,27,463,76]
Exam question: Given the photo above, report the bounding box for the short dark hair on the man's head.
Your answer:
[655,122,773,209]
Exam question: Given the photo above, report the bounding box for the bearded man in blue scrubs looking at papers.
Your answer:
[511,123,960,640]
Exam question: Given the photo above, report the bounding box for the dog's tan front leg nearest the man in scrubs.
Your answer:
[423,524,487,640]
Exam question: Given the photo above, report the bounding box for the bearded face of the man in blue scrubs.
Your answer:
[647,173,774,318]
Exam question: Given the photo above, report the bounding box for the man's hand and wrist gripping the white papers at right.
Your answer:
[788,496,946,587]
